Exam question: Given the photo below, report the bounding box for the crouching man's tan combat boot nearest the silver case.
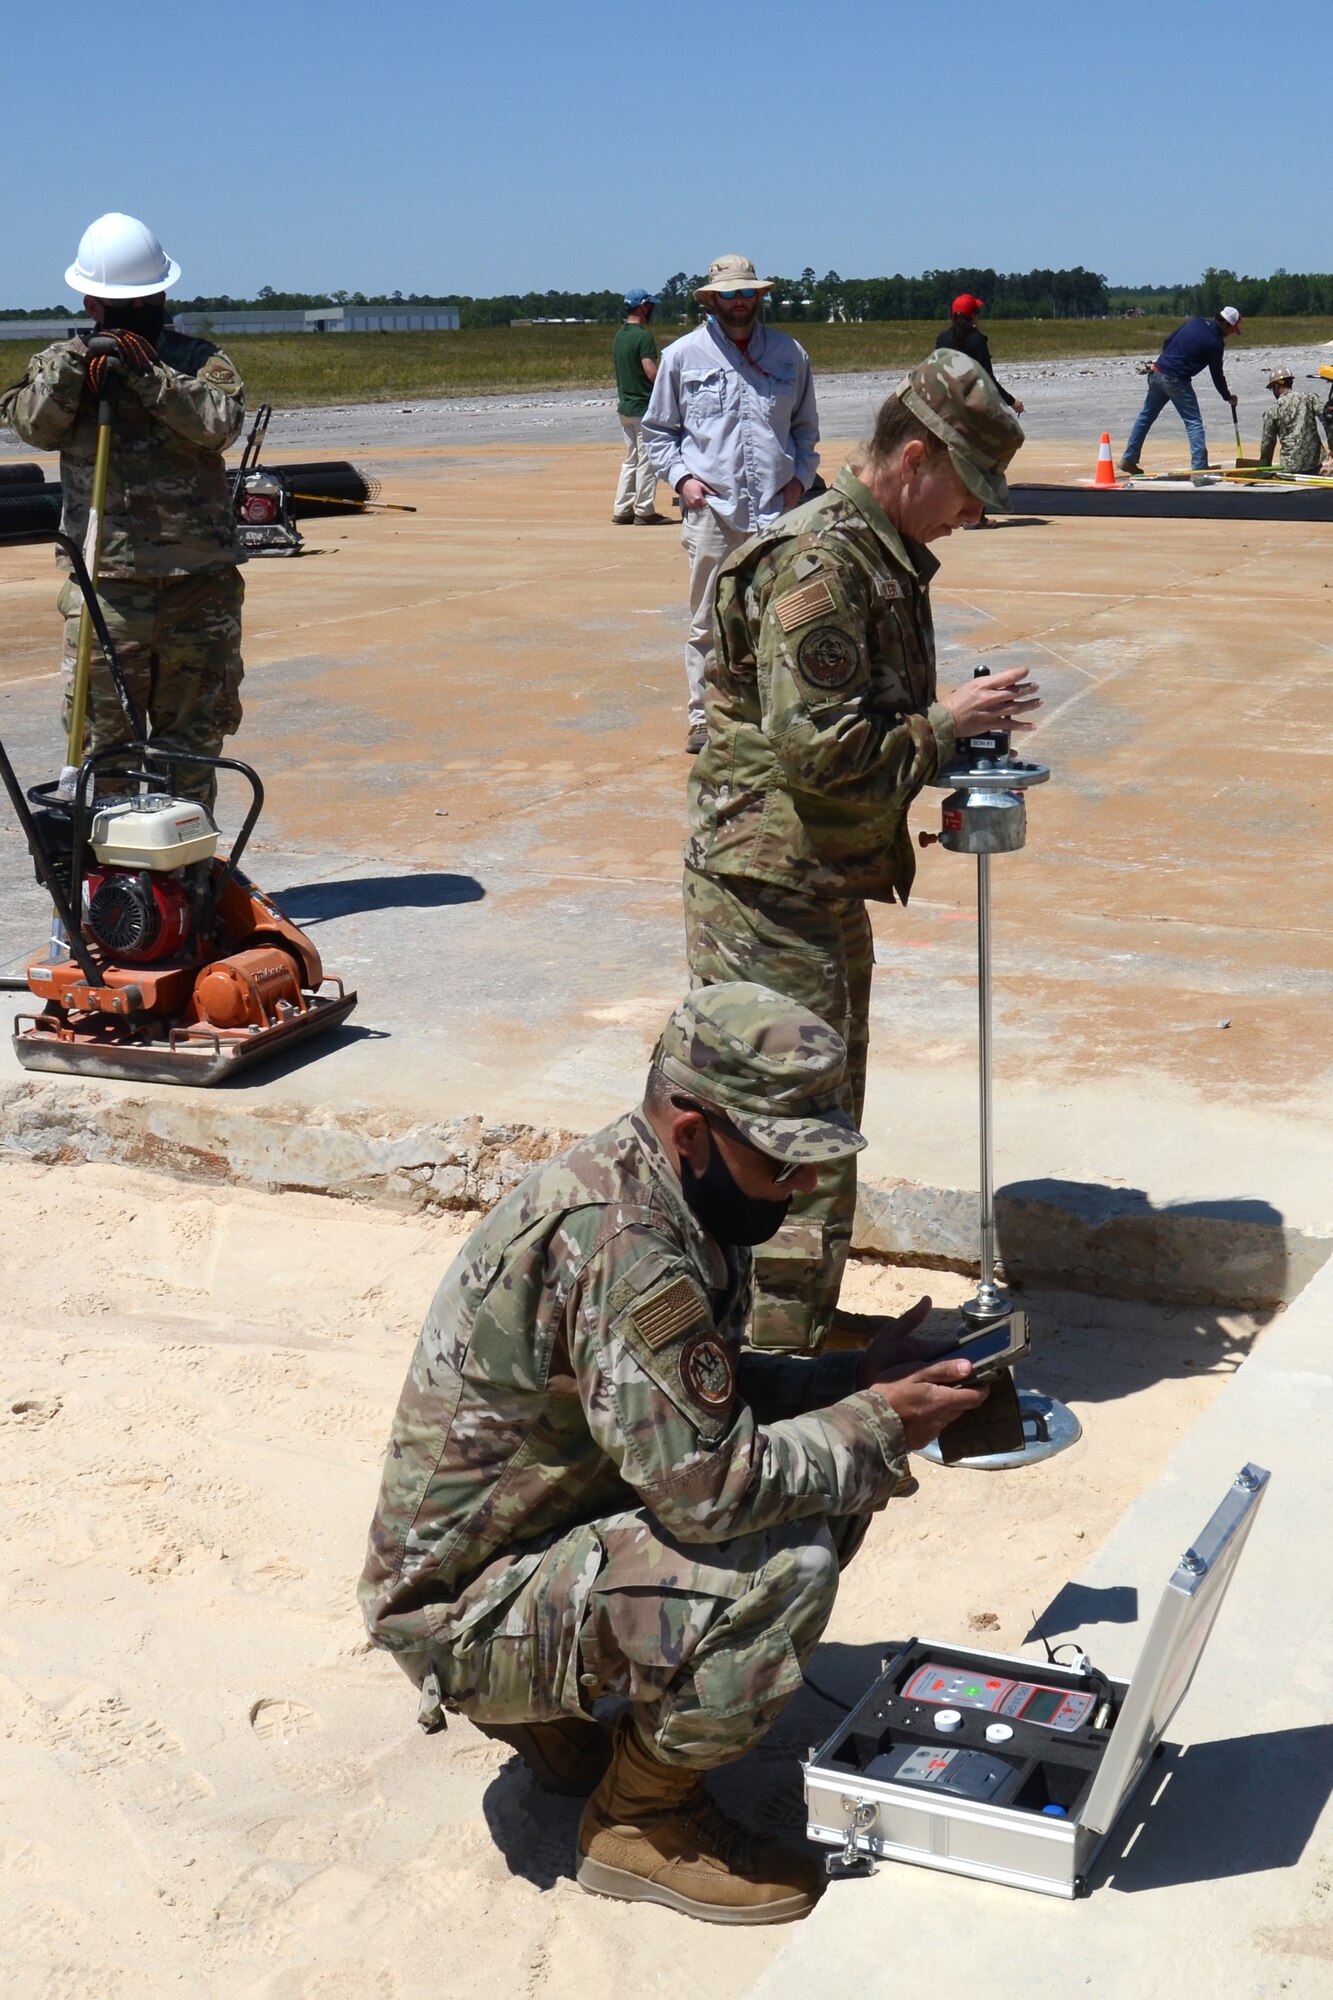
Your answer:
[576,1716,825,1924]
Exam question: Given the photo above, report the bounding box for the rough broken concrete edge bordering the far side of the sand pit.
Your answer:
[0,1080,1333,1308]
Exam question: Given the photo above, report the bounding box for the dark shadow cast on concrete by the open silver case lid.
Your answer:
[1093,1722,1333,1896]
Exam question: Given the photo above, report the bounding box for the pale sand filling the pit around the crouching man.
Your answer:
[0,1164,1255,2000]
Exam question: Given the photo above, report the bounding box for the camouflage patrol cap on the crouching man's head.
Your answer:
[652,980,865,1166]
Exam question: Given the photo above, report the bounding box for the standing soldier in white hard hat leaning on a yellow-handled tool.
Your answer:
[0,214,244,806]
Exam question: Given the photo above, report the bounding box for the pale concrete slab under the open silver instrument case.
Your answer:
[736,1232,1333,2000]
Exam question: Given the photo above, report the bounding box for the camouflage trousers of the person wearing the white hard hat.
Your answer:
[56,568,246,806]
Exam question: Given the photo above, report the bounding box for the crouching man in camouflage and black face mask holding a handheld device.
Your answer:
[360,984,985,1924]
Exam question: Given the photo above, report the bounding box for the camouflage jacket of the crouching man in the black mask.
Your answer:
[360,1112,905,1652]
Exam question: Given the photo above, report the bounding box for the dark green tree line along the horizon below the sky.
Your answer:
[0,264,1333,328]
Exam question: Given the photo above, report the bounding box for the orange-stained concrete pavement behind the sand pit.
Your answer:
[0,440,1333,1302]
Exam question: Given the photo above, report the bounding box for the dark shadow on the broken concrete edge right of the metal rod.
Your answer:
[995,1180,1296,1310]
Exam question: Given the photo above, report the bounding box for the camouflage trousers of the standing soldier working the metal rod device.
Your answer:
[685,868,875,1352]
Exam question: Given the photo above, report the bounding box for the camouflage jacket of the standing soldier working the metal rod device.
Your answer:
[685,468,955,902]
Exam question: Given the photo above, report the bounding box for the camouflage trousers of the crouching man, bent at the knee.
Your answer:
[396,1508,869,1770]
